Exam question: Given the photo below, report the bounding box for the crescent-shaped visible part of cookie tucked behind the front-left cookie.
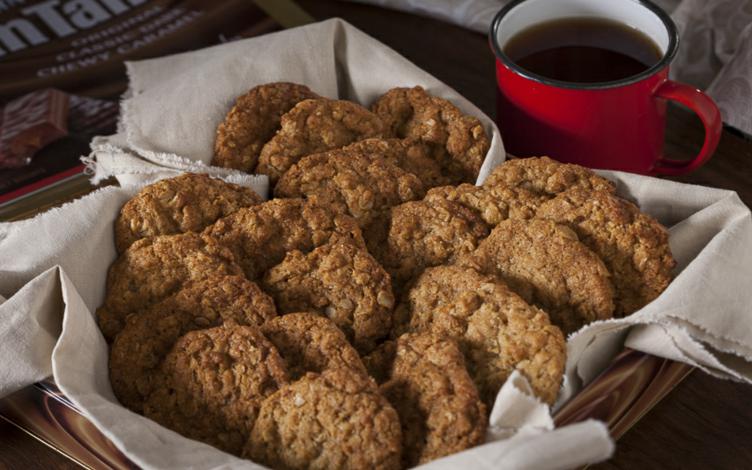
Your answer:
[110,276,277,413]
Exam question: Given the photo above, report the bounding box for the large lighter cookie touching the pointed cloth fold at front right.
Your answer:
[407,266,566,409]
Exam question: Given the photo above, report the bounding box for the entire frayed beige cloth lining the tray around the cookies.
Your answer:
[0,20,752,469]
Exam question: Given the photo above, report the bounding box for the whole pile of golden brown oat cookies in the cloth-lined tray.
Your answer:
[97,83,674,469]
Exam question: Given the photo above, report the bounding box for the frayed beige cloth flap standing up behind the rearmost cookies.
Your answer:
[86,16,504,195]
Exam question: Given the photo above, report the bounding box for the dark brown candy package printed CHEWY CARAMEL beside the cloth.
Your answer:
[0,0,281,206]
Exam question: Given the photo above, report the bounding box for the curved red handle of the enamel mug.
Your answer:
[653,80,723,175]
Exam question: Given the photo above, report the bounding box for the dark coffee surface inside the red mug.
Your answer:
[504,18,663,83]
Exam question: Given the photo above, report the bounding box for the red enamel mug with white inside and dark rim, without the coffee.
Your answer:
[489,0,722,175]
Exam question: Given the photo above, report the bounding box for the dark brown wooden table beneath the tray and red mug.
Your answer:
[0,0,752,469]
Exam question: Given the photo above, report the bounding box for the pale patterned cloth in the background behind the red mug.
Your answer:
[350,0,752,134]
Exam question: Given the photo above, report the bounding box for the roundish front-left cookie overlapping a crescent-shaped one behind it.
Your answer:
[144,325,289,455]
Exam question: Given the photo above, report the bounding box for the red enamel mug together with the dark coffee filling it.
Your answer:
[489,0,722,175]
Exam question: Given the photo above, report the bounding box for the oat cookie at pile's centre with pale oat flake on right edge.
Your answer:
[262,237,394,352]
